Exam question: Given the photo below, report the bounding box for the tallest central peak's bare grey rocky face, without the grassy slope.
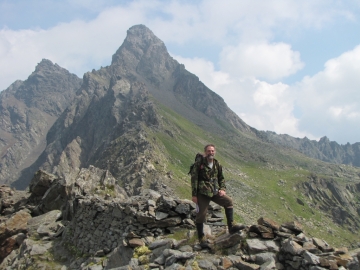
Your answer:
[9,25,250,194]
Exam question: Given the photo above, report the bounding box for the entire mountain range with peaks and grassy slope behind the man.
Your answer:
[0,25,360,247]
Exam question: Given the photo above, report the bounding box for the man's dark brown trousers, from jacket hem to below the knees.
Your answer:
[196,194,233,223]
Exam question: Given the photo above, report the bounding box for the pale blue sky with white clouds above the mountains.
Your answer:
[0,0,360,144]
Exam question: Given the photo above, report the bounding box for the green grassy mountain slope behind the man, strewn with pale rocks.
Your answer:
[151,101,360,249]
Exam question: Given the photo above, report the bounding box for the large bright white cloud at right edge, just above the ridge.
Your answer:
[294,46,360,143]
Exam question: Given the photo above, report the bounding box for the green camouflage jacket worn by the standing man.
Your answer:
[191,158,226,197]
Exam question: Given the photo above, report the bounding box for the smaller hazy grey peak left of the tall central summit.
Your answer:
[0,59,82,188]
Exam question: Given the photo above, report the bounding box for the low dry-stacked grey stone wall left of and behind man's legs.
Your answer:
[63,191,223,255]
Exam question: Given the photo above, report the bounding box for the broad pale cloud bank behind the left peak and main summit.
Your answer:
[0,3,148,90]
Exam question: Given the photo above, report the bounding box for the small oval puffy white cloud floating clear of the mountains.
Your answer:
[220,42,304,81]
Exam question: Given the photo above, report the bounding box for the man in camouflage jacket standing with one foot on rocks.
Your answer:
[191,144,244,247]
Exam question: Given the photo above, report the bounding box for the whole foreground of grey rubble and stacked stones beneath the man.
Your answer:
[0,167,360,270]
